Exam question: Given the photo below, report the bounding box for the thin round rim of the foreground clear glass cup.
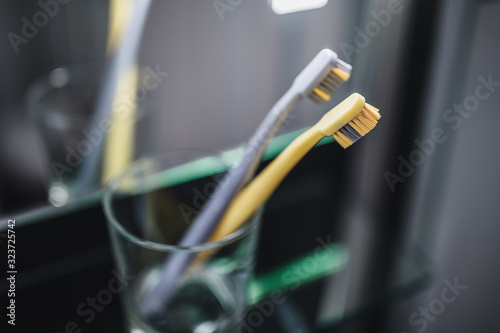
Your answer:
[102,149,262,253]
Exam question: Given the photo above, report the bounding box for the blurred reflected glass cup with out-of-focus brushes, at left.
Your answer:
[26,63,158,207]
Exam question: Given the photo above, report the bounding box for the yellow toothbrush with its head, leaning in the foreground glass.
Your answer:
[207,93,380,241]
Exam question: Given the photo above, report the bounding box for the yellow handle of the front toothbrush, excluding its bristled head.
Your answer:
[210,127,324,241]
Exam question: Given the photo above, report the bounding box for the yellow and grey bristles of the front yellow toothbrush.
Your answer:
[333,103,380,149]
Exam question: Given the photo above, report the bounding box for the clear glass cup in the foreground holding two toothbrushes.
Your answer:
[103,150,261,333]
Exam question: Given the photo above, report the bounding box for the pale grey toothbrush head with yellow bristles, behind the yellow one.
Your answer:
[294,49,352,104]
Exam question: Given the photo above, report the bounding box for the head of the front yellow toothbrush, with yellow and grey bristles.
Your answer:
[316,93,380,149]
